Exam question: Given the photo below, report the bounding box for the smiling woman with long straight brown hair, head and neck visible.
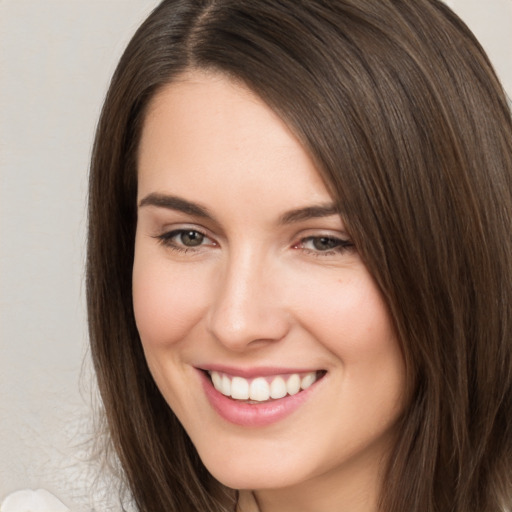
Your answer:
[88,0,512,512]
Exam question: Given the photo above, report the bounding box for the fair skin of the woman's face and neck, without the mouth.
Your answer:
[133,71,405,512]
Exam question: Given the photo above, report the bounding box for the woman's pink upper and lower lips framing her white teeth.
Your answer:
[197,366,325,427]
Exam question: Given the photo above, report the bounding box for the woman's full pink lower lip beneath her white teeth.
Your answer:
[199,370,318,427]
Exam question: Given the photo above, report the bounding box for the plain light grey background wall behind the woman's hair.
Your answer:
[0,0,512,510]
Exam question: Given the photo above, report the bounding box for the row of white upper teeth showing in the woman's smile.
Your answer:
[209,371,318,402]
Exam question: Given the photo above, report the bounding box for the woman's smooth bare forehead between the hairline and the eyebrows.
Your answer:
[138,72,329,214]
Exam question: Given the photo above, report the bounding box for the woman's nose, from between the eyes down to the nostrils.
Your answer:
[207,249,290,352]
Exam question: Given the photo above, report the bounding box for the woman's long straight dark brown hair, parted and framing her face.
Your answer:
[87,0,512,512]
